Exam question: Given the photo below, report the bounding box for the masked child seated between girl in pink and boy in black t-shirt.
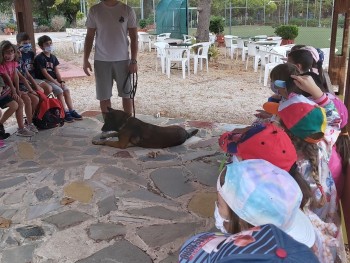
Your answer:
[16,32,52,95]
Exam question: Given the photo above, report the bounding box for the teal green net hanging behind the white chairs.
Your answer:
[156,0,188,38]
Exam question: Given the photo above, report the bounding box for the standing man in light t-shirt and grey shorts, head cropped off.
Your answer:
[83,0,138,115]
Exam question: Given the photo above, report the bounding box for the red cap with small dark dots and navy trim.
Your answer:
[219,123,297,171]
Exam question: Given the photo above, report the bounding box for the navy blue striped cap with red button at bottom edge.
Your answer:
[178,224,319,263]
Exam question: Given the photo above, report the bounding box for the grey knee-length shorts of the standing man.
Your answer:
[94,60,131,100]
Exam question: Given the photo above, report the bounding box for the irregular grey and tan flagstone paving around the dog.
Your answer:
[0,111,246,263]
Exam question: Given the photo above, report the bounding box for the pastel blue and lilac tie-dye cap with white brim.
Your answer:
[217,159,315,247]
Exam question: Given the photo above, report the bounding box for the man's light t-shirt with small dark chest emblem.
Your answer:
[86,1,137,61]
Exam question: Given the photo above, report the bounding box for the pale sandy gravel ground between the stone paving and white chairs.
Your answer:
[56,42,271,124]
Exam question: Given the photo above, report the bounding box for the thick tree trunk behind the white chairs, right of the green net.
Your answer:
[197,0,211,42]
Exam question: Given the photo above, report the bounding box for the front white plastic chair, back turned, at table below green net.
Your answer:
[165,47,190,79]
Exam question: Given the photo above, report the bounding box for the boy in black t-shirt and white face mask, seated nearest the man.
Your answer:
[34,35,83,122]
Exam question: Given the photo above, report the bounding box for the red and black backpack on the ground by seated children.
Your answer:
[33,91,64,129]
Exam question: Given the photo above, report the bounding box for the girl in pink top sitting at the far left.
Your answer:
[0,40,38,137]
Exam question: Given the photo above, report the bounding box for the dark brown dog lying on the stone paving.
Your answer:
[92,108,198,149]
